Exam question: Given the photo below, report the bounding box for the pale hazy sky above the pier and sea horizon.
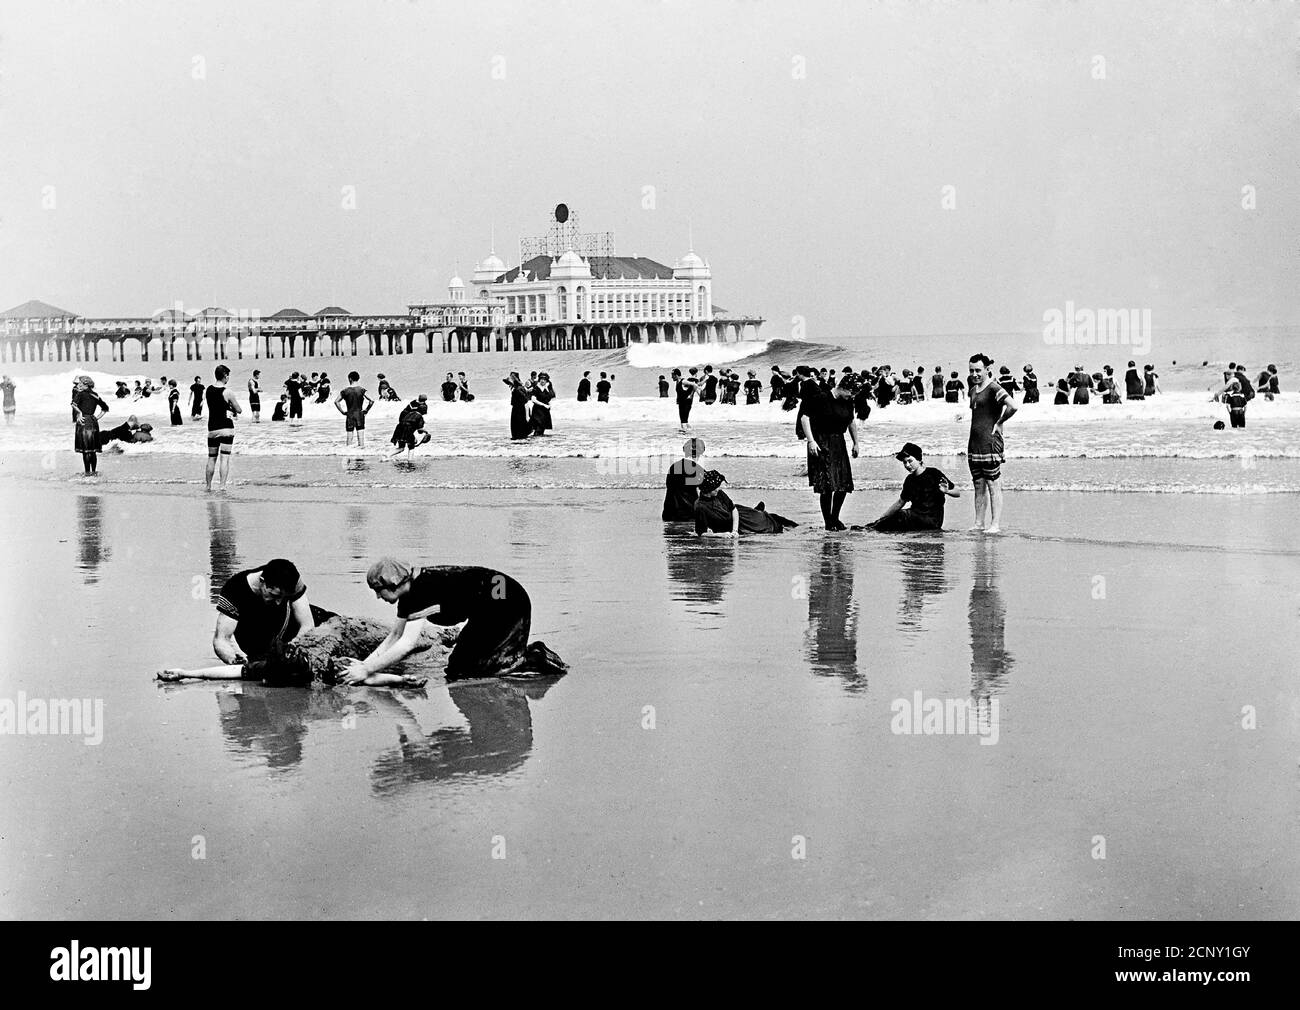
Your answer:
[0,0,1300,341]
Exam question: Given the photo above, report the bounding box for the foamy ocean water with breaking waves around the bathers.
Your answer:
[0,328,1300,494]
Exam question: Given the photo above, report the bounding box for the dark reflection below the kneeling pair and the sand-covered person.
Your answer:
[200,679,555,796]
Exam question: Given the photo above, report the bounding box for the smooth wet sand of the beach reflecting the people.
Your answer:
[0,480,1300,919]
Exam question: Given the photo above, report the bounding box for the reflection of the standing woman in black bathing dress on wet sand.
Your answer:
[806,537,867,692]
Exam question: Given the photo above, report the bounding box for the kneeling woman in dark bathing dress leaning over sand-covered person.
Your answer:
[343,558,568,684]
